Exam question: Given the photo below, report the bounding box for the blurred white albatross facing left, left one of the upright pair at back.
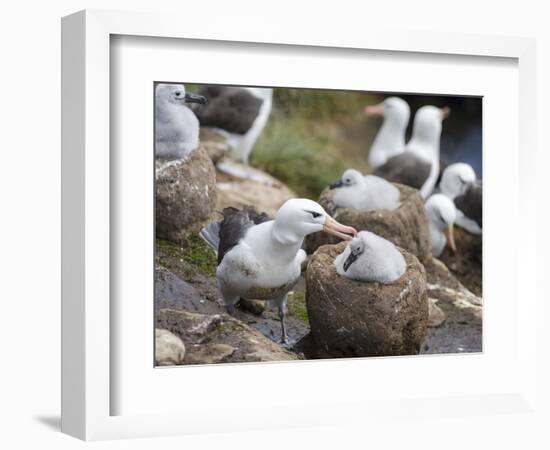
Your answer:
[364,97,411,170]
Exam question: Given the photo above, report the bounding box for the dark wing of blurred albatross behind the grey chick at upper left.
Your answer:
[194,86,263,134]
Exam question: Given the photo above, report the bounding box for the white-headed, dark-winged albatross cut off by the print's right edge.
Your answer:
[439,163,483,234]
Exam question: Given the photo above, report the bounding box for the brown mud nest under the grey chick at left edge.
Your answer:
[155,146,216,242]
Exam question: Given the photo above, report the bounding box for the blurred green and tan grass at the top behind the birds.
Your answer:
[251,89,378,198]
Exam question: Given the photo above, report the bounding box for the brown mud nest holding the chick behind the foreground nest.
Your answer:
[305,184,432,262]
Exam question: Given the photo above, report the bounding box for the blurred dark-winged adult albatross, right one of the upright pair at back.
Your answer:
[372,105,450,199]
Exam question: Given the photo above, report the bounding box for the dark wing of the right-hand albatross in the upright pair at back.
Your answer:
[372,152,432,189]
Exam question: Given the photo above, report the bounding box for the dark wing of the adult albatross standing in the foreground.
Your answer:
[218,206,269,265]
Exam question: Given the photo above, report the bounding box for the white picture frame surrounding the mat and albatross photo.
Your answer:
[62,10,536,440]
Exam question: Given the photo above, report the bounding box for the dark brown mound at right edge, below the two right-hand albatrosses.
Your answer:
[439,226,483,296]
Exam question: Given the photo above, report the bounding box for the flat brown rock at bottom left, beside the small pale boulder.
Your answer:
[156,308,299,364]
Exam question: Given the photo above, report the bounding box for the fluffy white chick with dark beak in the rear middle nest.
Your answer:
[330,169,400,211]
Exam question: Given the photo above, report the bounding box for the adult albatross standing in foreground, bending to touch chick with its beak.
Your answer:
[200,199,357,344]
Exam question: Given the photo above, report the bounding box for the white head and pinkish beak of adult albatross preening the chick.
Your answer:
[273,198,357,245]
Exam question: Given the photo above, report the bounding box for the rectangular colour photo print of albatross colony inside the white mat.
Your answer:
[154,80,483,366]
